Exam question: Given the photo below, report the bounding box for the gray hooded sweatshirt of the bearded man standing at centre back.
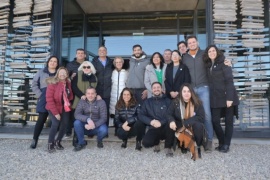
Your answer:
[127,55,150,88]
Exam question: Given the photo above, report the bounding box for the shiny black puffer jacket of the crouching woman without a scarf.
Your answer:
[114,106,138,127]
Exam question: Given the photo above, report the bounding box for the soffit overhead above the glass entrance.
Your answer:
[76,0,205,14]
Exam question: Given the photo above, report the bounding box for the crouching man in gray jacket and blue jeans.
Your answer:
[74,87,108,151]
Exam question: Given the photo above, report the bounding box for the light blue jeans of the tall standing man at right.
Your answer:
[194,86,214,141]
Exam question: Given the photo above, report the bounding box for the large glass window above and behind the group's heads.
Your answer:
[87,11,199,56]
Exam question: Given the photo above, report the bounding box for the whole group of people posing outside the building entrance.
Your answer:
[30,36,239,157]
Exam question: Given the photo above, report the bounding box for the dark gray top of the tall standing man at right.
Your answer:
[183,49,208,87]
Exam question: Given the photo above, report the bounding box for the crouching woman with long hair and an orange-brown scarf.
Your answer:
[165,83,204,160]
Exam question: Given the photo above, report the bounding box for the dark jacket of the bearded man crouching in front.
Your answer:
[138,95,171,128]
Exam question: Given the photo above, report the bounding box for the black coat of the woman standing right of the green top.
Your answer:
[164,63,191,98]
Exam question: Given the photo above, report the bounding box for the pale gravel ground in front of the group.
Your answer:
[0,131,270,180]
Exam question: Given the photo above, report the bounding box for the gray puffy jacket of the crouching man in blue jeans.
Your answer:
[74,99,107,127]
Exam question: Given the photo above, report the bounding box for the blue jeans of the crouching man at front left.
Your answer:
[74,120,108,144]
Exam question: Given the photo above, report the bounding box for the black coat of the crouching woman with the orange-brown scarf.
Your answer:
[167,98,205,128]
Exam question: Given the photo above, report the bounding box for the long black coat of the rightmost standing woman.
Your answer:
[207,55,239,108]
